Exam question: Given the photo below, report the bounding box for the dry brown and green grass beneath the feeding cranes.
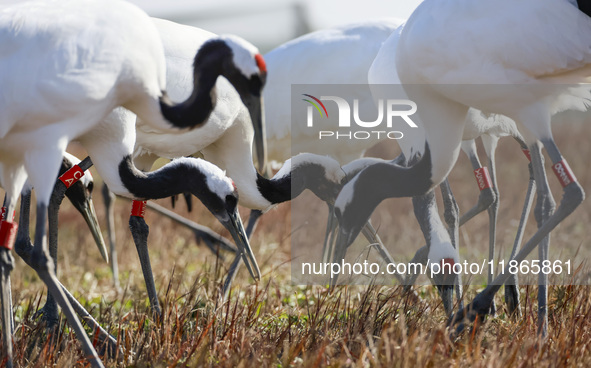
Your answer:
[1,115,591,367]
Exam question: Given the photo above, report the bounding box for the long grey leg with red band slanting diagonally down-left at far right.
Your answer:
[448,139,585,336]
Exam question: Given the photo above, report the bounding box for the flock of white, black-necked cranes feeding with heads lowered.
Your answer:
[0,0,591,367]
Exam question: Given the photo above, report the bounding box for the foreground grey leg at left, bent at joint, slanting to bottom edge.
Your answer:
[25,203,104,367]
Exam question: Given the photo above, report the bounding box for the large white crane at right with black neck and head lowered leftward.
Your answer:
[335,0,591,336]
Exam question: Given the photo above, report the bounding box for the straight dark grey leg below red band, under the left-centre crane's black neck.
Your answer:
[129,216,162,318]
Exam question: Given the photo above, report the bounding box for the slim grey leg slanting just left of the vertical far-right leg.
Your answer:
[505,163,536,319]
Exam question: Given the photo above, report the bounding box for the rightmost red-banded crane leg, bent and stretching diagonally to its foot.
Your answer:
[448,138,585,336]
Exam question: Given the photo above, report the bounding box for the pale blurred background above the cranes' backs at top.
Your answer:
[130,0,421,53]
